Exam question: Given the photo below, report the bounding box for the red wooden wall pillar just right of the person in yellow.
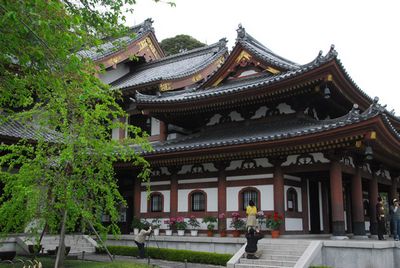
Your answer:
[270,158,285,233]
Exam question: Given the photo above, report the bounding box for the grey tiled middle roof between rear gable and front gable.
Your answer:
[113,39,228,94]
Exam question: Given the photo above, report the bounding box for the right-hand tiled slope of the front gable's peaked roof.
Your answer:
[236,24,300,70]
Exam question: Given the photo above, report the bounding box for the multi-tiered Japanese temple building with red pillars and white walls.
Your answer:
[0,19,400,236]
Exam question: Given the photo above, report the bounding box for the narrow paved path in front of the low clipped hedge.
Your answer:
[85,254,224,268]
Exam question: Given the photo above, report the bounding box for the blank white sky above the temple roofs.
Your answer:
[128,0,400,116]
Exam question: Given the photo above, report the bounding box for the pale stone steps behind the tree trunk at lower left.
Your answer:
[25,234,97,254]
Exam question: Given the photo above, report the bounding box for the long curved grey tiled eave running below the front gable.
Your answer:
[136,45,337,104]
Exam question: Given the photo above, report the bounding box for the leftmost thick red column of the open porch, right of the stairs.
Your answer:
[329,158,346,236]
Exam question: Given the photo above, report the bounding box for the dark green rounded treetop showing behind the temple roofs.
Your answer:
[160,34,205,56]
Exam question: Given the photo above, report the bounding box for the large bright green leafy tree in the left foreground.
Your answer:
[0,0,166,267]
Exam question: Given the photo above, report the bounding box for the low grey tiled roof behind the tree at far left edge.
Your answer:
[0,117,60,142]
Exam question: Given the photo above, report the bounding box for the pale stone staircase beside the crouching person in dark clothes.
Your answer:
[234,239,310,268]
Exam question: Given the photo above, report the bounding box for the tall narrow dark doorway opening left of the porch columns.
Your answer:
[309,180,321,234]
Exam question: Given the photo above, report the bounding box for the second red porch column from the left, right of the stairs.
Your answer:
[351,163,365,236]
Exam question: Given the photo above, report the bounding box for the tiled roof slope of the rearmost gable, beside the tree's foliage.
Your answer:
[78,18,153,61]
